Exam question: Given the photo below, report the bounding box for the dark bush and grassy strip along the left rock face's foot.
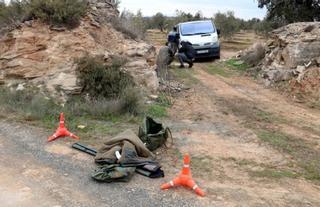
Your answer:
[0,55,172,142]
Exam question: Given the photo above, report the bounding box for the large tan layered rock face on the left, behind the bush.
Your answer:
[0,0,158,99]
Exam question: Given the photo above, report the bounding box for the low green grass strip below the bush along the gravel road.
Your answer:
[0,85,141,139]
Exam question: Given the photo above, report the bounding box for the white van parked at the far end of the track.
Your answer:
[175,20,220,59]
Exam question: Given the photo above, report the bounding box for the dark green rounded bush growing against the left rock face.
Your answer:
[77,56,140,114]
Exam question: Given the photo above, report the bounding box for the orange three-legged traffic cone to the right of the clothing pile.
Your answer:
[161,155,205,196]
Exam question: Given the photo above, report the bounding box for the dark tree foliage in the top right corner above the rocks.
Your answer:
[258,0,320,24]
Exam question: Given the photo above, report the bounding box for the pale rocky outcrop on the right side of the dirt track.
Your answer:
[240,22,320,100]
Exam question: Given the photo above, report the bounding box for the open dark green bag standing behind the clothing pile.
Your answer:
[139,117,172,151]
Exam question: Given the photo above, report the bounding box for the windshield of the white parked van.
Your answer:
[180,21,215,36]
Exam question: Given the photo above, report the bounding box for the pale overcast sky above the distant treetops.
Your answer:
[120,0,266,19]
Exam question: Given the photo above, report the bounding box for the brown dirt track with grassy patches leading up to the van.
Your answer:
[165,57,320,207]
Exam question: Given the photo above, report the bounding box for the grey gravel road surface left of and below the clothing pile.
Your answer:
[0,120,200,207]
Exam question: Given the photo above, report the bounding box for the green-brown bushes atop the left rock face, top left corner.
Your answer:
[0,0,87,30]
